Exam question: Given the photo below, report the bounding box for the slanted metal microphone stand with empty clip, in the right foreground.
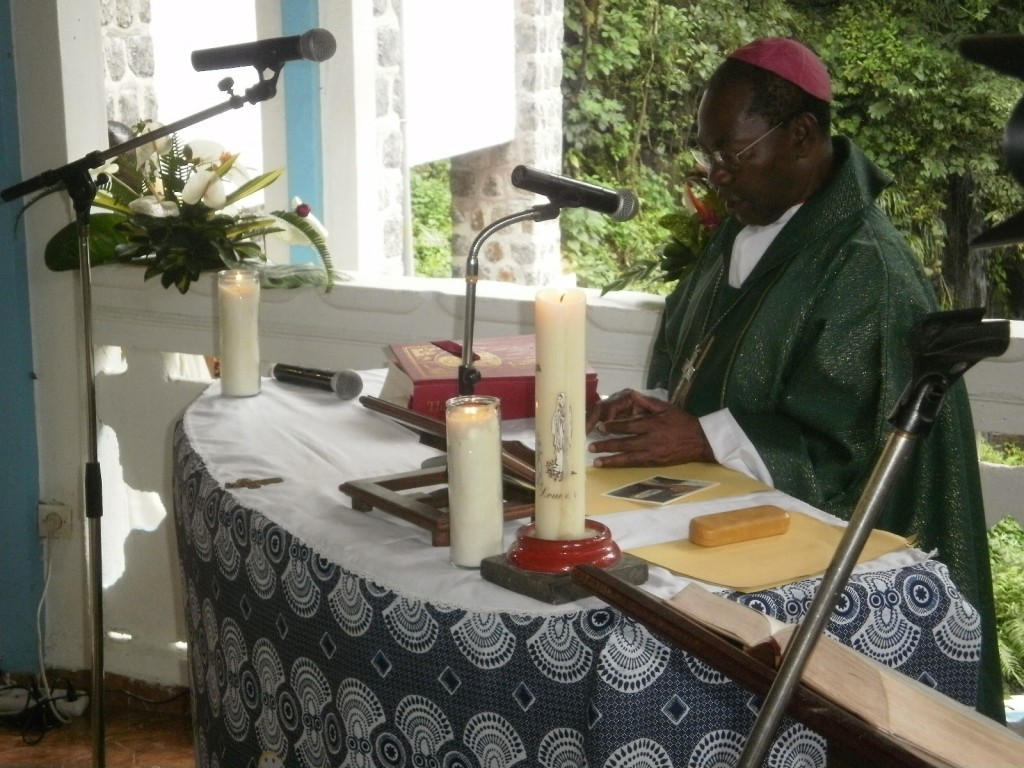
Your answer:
[737,308,1010,768]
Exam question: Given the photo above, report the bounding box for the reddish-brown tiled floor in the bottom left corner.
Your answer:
[0,705,196,768]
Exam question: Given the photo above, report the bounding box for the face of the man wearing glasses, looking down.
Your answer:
[697,83,800,225]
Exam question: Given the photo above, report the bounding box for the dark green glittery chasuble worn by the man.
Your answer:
[647,137,1004,721]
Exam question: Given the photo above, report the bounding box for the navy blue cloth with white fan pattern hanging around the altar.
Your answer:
[174,423,980,768]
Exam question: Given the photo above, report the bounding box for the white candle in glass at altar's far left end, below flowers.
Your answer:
[217,269,260,397]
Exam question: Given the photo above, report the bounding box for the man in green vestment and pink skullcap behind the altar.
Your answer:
[588,38,1005,721]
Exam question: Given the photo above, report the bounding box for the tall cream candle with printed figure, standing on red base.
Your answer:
[534,288,589,540]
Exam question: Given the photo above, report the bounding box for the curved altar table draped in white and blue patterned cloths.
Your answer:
[173,371,980,768]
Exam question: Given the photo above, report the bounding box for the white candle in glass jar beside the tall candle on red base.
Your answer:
[444,395,505,568]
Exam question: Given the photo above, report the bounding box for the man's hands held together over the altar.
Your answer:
[587,389,715,467]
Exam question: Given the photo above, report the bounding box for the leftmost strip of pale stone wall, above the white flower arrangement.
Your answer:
[100,0,157,125]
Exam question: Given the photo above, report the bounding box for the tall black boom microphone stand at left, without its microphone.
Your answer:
[0,63,283,768]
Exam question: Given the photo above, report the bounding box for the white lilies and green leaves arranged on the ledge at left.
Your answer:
[37,122,335,293]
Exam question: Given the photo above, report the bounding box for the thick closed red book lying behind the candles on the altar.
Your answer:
[381,334,598,419]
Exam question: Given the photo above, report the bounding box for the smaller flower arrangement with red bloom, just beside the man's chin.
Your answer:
[601,166,724,295]
